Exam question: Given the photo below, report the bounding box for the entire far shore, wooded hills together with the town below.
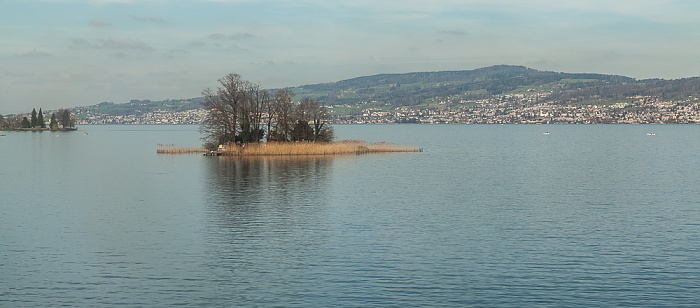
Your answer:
[8,65,700,129]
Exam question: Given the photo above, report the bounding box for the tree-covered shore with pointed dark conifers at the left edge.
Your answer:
[0,108,78,132]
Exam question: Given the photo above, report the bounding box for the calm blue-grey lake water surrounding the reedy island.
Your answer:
[0,125,700,307]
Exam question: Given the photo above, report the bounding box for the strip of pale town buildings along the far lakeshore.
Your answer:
[72,92,700,125]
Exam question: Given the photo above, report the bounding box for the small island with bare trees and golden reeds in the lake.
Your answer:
[157,74,422,156]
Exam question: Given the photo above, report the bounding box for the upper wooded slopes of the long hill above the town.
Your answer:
[291,65,700,106]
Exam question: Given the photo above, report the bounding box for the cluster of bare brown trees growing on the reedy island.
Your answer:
[200,74,334,144]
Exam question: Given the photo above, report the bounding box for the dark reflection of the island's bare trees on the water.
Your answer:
[206,156,332,236]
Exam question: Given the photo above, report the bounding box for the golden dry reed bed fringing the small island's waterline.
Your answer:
[157,140,422,156]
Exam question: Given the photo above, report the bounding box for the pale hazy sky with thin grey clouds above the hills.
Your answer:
[0,0,700,114]
